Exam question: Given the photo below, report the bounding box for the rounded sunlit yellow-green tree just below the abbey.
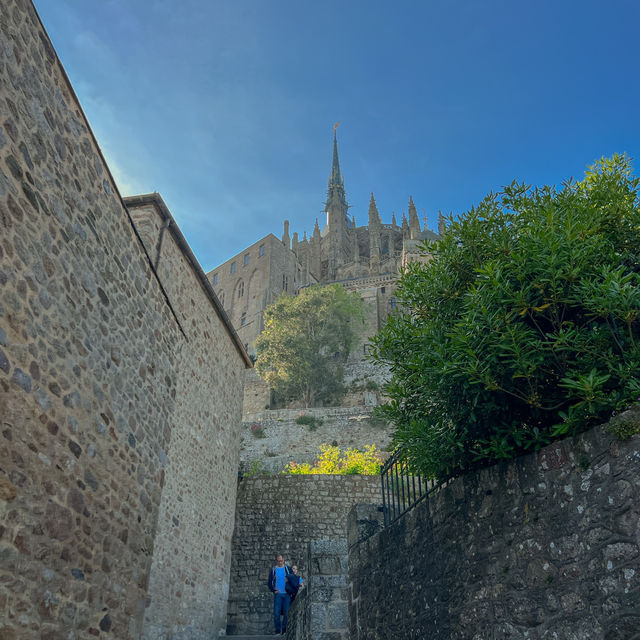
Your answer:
[256,284,363,407]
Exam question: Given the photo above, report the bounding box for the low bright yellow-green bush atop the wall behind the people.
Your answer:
[283,444,382,476]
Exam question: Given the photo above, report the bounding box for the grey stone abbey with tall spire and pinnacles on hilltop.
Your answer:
[207,129,443,355]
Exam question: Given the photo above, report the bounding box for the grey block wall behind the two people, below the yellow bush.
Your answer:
[227,475,380,634]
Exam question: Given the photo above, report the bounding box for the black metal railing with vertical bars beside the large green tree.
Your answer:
[380,449,445,527]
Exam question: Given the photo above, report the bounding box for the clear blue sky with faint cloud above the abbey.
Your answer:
[35,0,640,270]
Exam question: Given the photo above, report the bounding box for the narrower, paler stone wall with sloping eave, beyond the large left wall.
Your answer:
[125,194,245,640]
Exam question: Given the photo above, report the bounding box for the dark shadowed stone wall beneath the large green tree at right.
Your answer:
[349,415,640,640]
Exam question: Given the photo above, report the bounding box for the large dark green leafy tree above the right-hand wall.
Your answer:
[372,155,640,478]
